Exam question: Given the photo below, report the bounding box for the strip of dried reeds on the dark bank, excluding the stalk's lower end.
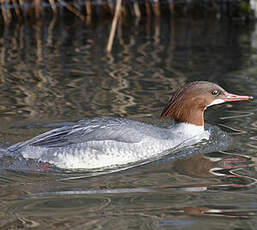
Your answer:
[0,0,253,24]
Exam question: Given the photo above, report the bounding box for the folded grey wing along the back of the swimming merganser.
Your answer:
[9,118,142,151]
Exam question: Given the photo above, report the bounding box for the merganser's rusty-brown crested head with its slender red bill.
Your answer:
[161,81,252,126]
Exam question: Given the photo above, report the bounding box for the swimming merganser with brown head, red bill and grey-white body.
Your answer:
[7,81,252,169]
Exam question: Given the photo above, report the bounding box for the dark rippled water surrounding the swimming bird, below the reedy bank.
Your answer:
[0,18,257,230]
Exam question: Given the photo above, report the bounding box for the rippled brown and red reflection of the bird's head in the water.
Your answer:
[174,151,254,191]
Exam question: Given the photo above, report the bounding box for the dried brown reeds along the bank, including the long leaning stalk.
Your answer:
[0,0,251,52]
